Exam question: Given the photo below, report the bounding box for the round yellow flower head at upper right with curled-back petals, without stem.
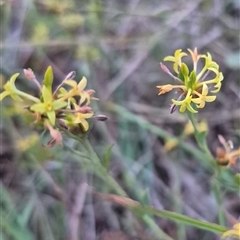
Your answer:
[157,48,223,113]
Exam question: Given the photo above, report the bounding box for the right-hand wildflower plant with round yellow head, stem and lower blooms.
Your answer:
[157,48,240,239]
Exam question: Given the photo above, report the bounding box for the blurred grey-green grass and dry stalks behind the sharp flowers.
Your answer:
[0,0,240,240]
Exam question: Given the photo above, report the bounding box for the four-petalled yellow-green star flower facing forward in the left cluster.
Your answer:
[30,85,67,126]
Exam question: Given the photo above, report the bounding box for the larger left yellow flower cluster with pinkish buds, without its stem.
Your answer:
[0,67,99,146]
